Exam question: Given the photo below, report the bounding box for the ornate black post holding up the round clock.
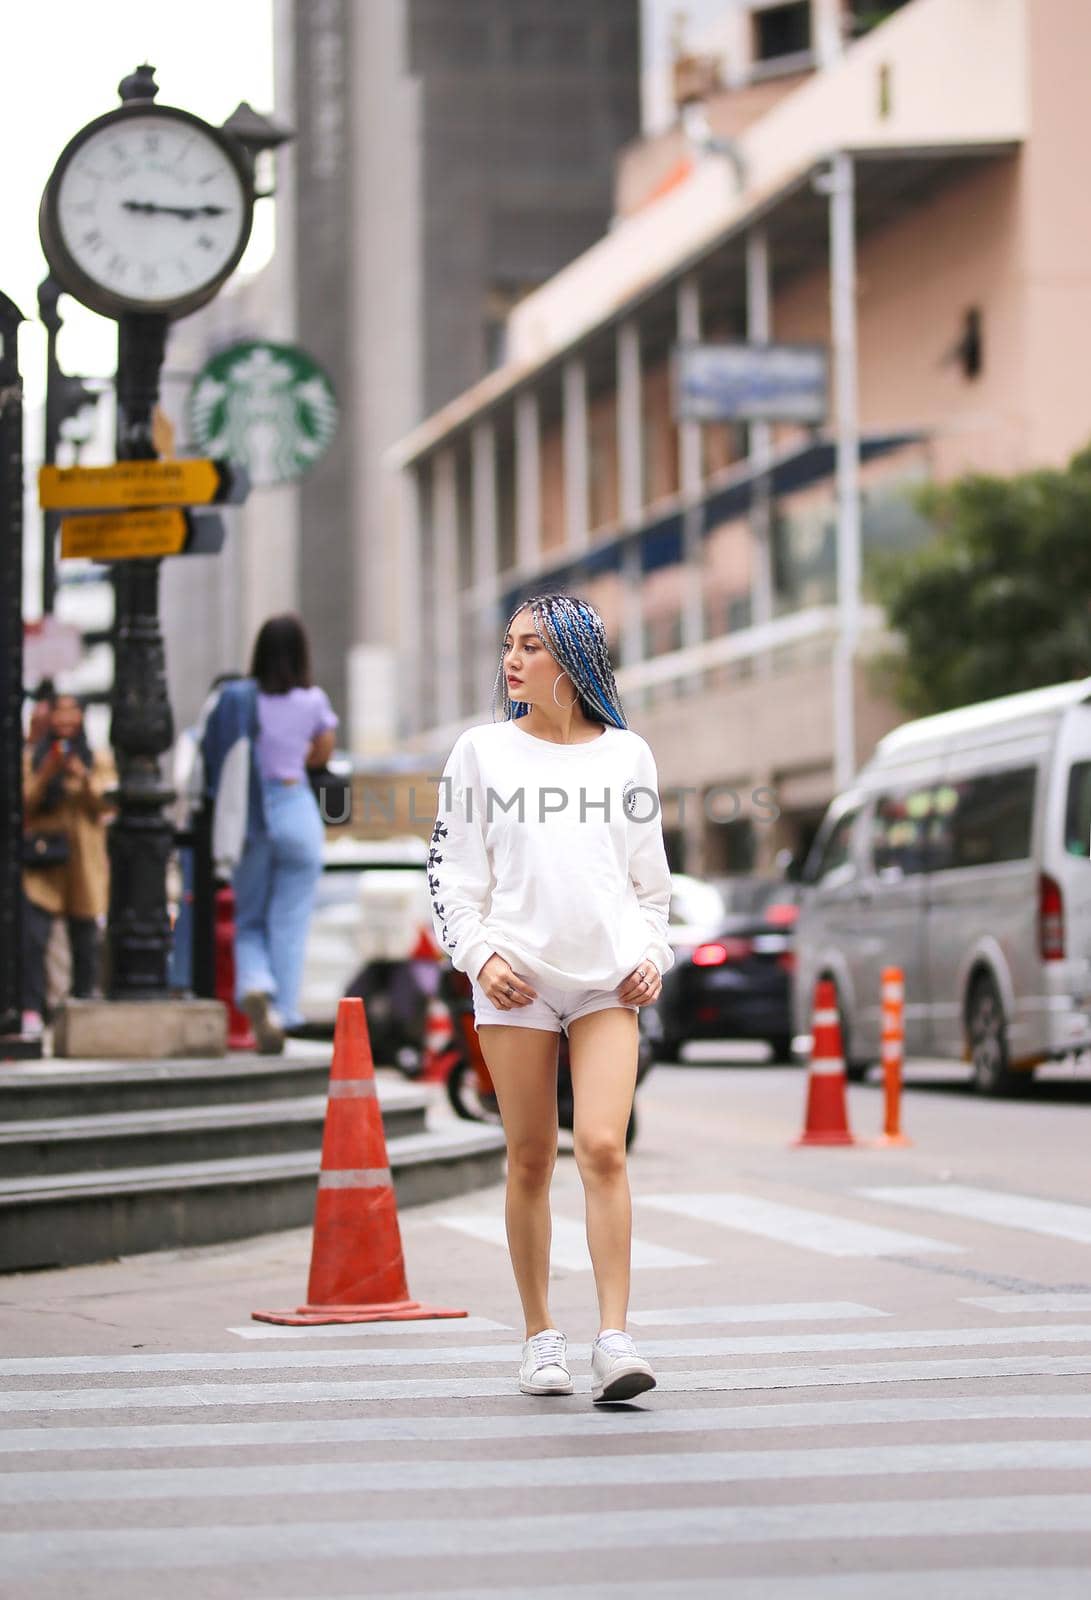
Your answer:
[109,70,174,1000]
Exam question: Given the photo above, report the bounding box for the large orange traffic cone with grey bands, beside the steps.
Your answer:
[251,998,466,1326]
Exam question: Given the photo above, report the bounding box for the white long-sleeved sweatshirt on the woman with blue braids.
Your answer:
[429,718,673,990]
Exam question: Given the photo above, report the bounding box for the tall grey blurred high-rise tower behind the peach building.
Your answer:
[288,0,640,755]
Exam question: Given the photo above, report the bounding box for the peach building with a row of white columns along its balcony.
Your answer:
[389,0,1091,872]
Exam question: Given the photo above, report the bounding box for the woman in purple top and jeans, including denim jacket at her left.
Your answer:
[202,613,338,1054]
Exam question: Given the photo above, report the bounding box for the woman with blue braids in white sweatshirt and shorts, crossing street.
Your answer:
[429,594,673,1402]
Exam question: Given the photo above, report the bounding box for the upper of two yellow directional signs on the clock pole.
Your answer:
[38,458,248,510]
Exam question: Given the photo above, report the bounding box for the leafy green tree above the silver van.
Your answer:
[873,448,1091,715]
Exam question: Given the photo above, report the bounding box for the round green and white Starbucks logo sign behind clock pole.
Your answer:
[189,339,338,488]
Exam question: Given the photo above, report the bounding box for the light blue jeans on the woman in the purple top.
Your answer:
[234,779,323,1027]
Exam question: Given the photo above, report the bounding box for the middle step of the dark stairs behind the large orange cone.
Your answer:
[0,1083,427,1178]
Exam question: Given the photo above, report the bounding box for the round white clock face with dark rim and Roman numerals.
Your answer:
[43,107,251,315]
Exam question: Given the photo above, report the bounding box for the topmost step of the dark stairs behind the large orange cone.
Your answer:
[0,1045,350,1123]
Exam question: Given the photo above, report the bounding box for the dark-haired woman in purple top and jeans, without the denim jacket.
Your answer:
[232,613,338,1054]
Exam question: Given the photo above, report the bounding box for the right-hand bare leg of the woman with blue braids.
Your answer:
[568,1006,640,1330]
